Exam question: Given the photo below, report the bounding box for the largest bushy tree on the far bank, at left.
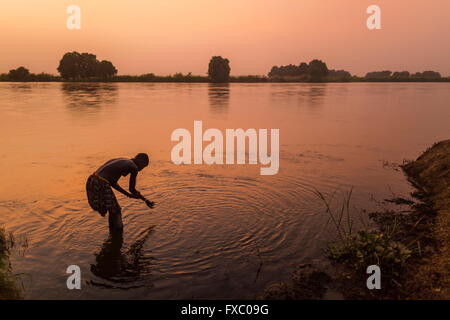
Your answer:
[58,51,117,79]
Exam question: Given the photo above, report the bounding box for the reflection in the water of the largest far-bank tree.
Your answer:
[61,82,118,113]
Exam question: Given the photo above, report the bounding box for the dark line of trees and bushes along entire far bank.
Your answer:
[0,51,450,83]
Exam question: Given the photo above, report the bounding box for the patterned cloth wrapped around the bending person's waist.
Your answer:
[86,173,121,216]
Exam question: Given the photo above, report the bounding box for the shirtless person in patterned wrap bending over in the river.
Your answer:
[86,153,153,230]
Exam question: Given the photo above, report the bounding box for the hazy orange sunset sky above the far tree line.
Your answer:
[0,0,450,76]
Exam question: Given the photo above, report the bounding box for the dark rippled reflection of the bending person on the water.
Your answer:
[90,226,154,289]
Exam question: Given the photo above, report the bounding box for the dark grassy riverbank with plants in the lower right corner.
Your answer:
[261,140,450,300]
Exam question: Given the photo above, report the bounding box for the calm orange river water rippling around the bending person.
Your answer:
[0,83,450,299]
